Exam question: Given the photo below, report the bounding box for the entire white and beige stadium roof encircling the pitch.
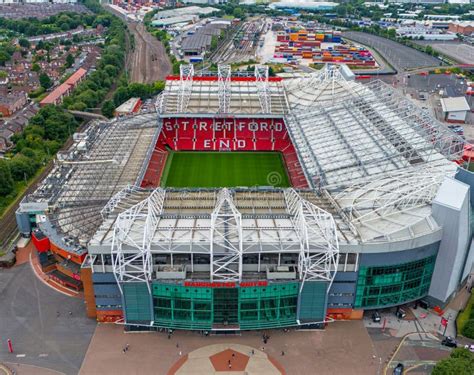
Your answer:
[25,66,464,251]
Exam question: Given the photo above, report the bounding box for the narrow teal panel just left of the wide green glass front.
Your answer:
[122,283,153,324]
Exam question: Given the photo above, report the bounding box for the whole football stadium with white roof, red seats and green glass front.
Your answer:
[17,65,474,332]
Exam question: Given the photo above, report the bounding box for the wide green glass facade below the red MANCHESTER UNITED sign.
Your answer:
[152,282,299,330]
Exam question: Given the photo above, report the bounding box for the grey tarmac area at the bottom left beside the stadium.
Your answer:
[0,262,96,374]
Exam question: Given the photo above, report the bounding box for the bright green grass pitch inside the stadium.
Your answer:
[161,151,290,188]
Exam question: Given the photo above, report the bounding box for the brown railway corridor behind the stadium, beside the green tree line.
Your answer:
[128,23,171,83]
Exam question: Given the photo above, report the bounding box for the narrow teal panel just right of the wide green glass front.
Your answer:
[298,281,328,323]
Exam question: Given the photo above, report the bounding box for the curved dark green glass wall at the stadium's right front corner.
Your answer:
[355,256,436,308]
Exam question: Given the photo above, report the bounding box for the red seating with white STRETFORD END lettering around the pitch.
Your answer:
[141,117,308,188]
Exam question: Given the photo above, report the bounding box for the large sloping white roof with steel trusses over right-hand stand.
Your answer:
[285,68,465,189]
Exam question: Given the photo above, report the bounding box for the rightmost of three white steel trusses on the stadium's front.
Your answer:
[285,189,339,290]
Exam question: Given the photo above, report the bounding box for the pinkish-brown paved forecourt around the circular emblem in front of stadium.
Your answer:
[80,321,379,375]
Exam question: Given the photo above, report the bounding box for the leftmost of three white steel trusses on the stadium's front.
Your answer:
[112,188,165,290]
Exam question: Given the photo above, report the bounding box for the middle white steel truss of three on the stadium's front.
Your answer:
[210,189,242,282]
